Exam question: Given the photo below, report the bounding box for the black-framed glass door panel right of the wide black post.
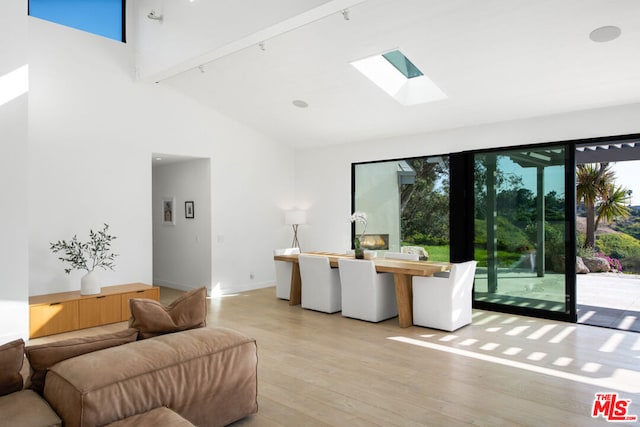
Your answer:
[473,145,575,320]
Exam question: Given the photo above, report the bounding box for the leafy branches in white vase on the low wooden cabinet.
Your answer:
[49,224,117,295]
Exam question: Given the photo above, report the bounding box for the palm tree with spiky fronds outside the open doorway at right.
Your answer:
[576,162,630,248]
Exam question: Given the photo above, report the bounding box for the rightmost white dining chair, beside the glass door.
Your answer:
[413,261,477,332]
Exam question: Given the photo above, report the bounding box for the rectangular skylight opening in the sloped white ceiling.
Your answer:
[351,50,447,105]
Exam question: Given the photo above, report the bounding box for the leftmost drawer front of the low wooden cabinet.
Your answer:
[29,301,78,338]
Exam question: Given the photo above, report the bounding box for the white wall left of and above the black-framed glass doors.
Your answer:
[296,104,640,251]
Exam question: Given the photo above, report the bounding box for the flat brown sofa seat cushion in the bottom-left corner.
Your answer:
[0,390,62,427]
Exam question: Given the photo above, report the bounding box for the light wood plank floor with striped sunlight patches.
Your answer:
[31,288,640,427]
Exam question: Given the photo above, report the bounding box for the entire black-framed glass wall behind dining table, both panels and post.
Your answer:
[352,143,576,321]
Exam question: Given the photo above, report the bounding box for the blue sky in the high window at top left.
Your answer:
[29,0,124,41]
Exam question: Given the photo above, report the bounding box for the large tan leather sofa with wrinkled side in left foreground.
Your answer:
[0,327,258,427]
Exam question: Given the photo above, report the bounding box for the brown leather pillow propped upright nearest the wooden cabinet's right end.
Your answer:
[129,287,207,340]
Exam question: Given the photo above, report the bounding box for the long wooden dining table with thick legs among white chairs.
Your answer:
[273,252,451,328]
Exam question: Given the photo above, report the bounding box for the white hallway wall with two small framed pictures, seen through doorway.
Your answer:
[153,159,211,292]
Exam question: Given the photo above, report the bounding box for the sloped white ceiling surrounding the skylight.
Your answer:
[138,0,640,148]
